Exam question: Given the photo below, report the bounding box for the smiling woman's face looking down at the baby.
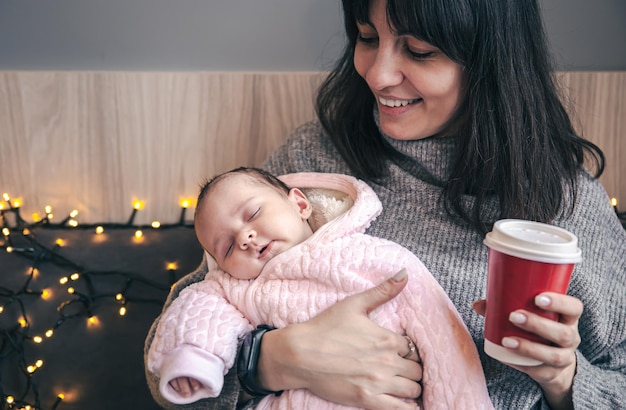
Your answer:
[354,0,463,140]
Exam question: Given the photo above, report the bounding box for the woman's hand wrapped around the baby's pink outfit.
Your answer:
[258,274,422,410]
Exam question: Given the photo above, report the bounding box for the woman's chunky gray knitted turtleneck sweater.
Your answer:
[146,122,626,410]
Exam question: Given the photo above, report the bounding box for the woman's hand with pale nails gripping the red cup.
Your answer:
[473,292,583,409]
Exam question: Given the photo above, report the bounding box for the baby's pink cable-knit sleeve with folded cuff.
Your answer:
[147,278,252,404]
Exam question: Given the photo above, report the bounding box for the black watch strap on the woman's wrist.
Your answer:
[237,325,283,397]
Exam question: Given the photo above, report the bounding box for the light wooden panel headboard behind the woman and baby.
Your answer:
[0,71,626,224]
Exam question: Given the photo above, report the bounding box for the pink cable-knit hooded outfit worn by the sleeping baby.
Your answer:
[148,173,493,410]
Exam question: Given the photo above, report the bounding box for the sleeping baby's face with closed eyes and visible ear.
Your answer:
[195,175,312,279]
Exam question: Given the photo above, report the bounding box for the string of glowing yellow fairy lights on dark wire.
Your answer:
[0,193,193,410]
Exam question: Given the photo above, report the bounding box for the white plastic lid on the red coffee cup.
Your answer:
[483,219,582,263]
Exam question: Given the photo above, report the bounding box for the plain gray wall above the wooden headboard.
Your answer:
[0,0,626,71]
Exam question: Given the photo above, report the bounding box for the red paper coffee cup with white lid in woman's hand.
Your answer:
[484,219,582,366]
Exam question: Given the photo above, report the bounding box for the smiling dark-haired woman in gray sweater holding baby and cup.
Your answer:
[148,0,626,409]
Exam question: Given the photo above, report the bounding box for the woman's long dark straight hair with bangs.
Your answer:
[317,0,604,231]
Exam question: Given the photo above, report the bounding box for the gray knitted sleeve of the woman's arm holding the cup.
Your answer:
[565,175,626,409]
